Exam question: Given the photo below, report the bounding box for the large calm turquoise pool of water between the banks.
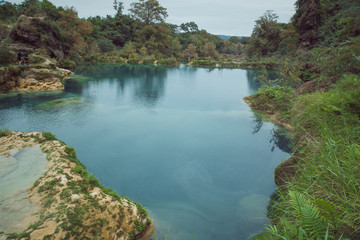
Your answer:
[0,64,290,240]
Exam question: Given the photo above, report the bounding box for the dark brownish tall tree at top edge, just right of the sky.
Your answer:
[292,0,322,49]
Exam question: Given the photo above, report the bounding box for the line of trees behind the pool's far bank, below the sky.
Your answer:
[0,0,246,64]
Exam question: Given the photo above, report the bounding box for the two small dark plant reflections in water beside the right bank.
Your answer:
[252,113,293,153]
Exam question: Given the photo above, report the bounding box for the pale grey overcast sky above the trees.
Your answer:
[8,0,296,36]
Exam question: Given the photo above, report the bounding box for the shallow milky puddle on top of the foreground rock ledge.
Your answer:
[0,145,47,232]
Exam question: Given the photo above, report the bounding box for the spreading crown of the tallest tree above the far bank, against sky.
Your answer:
[129,0,168,25]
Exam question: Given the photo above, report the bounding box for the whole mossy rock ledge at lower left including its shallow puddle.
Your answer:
[0,131,154,240]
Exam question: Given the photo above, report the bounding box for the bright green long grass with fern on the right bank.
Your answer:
[255,75,360,239]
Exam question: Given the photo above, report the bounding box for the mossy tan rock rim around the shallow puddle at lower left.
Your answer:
[0,132,153,240]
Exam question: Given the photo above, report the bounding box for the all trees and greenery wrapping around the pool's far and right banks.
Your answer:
[0,0,360,239]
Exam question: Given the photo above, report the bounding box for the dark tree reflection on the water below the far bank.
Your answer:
[72,64,178,107]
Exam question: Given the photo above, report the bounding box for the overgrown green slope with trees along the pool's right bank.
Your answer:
[248,0,360,239]
